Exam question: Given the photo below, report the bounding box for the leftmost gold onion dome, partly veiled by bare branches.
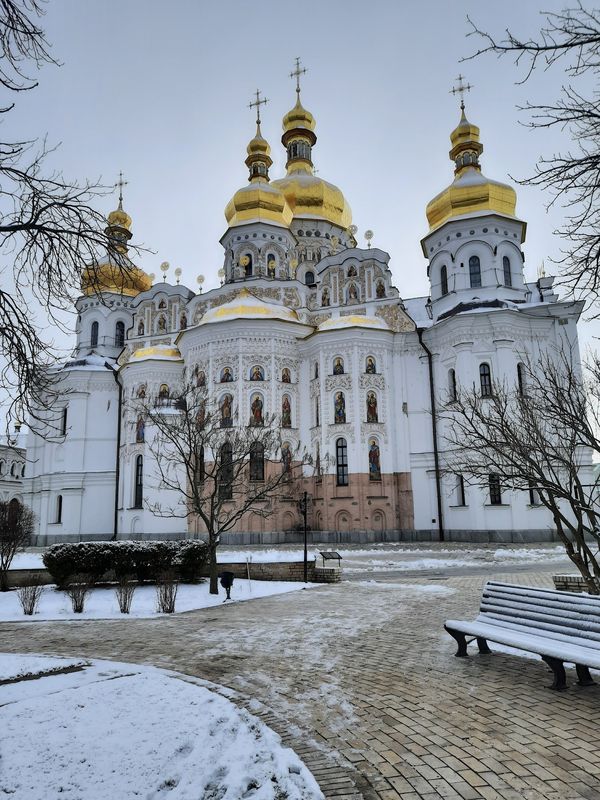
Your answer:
[81,202,152,297]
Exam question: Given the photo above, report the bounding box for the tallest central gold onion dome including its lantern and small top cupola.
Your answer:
[271,82,352,229]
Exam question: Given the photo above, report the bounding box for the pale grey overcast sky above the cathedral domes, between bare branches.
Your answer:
[6,0,591,352]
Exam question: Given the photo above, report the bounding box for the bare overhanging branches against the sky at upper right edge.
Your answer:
[465,2,600,316]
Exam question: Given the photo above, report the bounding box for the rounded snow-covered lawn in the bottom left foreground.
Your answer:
[0,656,323,800]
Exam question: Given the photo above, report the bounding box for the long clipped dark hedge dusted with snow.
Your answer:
[44,539,208,588]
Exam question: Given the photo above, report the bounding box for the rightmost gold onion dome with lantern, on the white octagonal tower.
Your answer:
[426,105,517,230]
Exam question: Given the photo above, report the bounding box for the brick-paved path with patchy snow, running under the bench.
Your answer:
[0,571,600,800]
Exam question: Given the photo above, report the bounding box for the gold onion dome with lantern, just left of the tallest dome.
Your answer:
[225,122,292,228]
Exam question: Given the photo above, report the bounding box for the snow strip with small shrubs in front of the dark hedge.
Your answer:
[0,578,318,622]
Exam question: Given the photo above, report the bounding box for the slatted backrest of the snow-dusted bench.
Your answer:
[479,581,600,646]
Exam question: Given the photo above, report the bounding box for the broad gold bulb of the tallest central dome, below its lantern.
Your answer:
[271,172,352,228]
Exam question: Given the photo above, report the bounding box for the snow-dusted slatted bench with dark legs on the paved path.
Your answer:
[444,581,600,690]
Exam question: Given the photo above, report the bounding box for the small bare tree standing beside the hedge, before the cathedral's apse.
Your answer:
[131,383,308,594]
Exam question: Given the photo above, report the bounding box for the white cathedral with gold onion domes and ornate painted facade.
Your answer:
[22,69,582,544]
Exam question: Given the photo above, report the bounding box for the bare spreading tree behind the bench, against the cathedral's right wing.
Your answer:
[440,352,600,594]
